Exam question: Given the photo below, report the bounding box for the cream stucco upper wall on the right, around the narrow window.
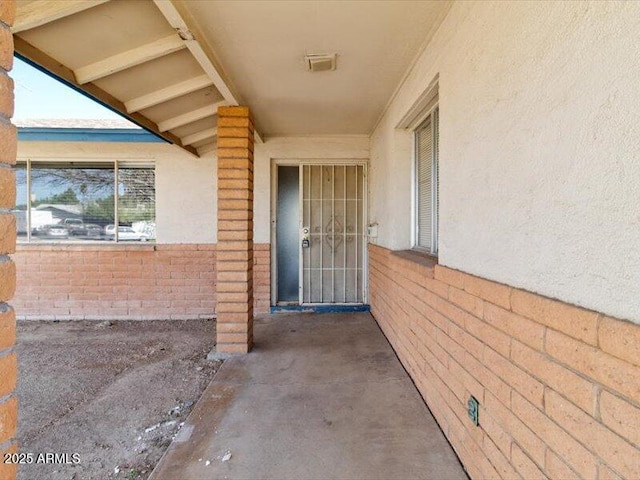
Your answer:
[369,2,640,322]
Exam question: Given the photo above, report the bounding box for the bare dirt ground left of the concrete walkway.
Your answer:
[17,320,220,480]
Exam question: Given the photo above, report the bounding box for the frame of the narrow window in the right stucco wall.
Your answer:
[412,104,440,257]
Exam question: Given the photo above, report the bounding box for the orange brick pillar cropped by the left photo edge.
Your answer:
[0,0,18,479]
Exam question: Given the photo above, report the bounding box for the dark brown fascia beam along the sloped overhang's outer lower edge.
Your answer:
[13,35,198,156]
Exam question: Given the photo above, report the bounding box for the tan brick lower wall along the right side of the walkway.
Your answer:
[369,246,640,480]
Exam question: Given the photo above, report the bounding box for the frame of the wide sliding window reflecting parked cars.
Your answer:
[14,158,157,245]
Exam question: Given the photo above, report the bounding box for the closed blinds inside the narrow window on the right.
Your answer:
[416,115,434,252]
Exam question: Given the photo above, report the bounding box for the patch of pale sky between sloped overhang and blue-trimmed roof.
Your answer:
[11,58,122,120]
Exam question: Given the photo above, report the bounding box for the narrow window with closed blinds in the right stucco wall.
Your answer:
[415,108,438,255]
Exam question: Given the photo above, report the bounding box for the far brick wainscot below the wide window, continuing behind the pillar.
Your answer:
[14,245,270,320]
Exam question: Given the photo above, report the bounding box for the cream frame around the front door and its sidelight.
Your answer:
[270,158,369,306]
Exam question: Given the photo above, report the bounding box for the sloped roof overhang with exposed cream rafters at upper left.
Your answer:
[12,0,248,155]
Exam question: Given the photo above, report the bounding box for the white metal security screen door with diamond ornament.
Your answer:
[301,165,364,303]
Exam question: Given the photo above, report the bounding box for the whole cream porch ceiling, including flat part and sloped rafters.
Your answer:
[12,0,450,155]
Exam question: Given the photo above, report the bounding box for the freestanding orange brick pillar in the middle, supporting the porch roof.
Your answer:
[216,107,253,353]
